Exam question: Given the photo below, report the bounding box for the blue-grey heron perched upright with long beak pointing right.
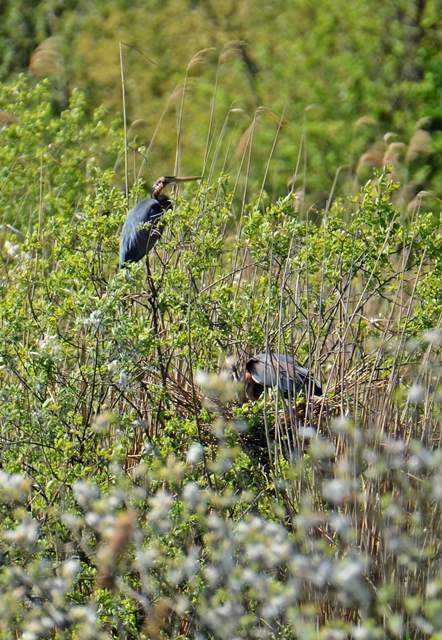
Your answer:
[120,176,202,269]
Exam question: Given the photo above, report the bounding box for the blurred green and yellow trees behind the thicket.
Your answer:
[0,0,442,209]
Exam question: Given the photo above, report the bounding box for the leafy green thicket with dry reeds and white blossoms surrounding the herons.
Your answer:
[0,79,442,640]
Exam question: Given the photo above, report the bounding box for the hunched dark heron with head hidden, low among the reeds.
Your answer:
[244,353,322,401]
